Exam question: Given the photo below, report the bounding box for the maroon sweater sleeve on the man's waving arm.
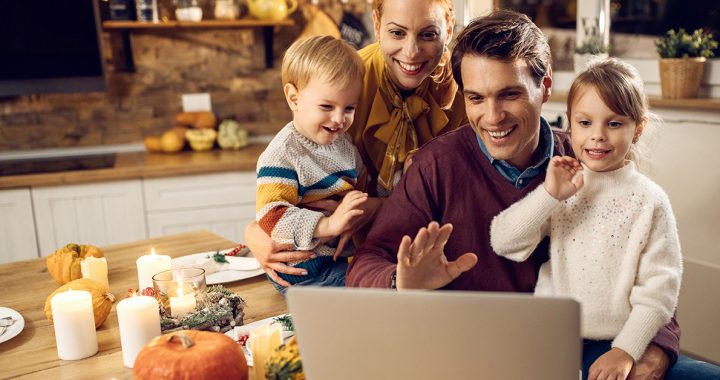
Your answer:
[345,156,434,288]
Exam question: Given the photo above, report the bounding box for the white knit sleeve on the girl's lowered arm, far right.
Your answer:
[613,198,682,361]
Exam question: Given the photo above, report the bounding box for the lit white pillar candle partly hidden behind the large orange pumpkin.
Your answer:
[117,294,160,368]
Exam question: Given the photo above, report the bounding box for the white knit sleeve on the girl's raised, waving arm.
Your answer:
[490,185,561,262]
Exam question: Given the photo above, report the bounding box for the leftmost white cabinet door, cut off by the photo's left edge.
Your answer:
[0,189,38,264]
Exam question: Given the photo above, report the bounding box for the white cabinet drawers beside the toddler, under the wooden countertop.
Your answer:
[143,172,255,242]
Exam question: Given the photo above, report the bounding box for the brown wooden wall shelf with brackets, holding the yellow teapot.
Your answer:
[102,19,295,72]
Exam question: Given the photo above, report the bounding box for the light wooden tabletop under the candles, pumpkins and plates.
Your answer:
[0,231,287,379]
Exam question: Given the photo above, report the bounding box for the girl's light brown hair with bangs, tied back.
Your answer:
[567,58,662,171]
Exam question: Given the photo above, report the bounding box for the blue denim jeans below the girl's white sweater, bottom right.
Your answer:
[582,340,720,380]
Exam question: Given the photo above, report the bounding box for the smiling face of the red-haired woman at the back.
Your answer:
[373,0,452,90]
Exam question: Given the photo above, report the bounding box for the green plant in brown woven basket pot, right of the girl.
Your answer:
[655,29,718,99]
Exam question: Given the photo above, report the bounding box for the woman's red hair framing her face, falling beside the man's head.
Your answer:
[372,0,458,108]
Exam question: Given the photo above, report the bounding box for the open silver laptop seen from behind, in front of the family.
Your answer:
[287,286,582,380]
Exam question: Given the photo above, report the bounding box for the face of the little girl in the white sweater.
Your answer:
[568,86,642,172]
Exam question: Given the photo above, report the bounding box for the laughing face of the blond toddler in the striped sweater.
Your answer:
[286,77,361,145]
